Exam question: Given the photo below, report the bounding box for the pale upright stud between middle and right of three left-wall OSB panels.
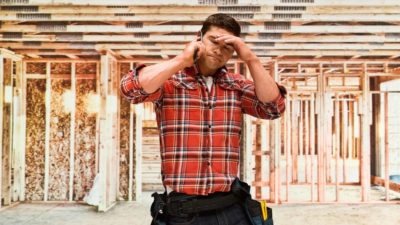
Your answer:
[69,62,76,202]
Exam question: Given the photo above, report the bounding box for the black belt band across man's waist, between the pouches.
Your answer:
[167,192,240,215]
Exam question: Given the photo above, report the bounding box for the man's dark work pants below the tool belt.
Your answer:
[168,203,251,225]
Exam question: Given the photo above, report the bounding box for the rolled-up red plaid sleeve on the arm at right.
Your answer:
[242,80,287,120]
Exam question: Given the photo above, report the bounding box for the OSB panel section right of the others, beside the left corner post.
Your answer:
[74,80,96,200]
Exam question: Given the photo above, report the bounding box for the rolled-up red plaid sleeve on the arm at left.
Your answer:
[120,65,162,104]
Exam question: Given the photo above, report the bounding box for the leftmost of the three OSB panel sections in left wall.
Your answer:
[25,79,46,200]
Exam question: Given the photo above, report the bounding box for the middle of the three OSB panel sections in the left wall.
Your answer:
[48,79,71,200]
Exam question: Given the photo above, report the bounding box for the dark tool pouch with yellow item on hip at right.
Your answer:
[247,199,274,225]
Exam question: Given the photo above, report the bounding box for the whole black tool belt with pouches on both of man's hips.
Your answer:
[151,179,273,225]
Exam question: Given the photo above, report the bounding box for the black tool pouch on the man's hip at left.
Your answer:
[150,192,167,225]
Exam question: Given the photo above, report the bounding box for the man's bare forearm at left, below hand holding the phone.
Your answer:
[139,56,185,93]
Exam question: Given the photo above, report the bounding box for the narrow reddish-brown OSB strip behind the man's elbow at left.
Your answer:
[119,63,134,199]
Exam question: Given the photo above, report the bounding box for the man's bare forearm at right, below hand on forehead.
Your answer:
[246,57,280,102]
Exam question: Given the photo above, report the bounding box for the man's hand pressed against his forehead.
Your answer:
[215,34,258,63]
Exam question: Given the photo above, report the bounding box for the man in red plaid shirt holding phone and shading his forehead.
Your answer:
[121,14,286,225]
